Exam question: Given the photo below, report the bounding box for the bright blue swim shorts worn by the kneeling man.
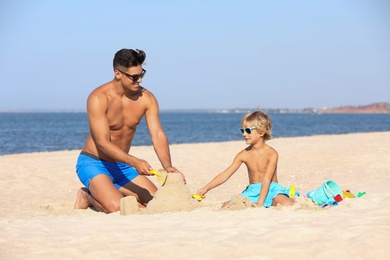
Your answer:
[76,152,139,189]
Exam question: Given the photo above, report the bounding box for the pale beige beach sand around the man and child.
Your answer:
[0,132,390,259]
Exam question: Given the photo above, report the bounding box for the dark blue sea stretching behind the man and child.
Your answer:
[0,112,390,155]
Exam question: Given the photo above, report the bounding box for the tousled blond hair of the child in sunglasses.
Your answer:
[241,110,272,140]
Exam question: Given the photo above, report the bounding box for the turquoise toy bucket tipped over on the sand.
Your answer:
[311,181,343,206]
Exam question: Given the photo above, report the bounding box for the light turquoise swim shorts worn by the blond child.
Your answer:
[241,182,289,208]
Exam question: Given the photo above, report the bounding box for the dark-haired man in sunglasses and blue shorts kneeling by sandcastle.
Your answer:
[74,49,184,213]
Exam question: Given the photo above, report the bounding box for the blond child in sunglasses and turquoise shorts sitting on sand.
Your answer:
[198,111,294,208]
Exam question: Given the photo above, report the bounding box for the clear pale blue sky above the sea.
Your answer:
[0,0,390,110]
